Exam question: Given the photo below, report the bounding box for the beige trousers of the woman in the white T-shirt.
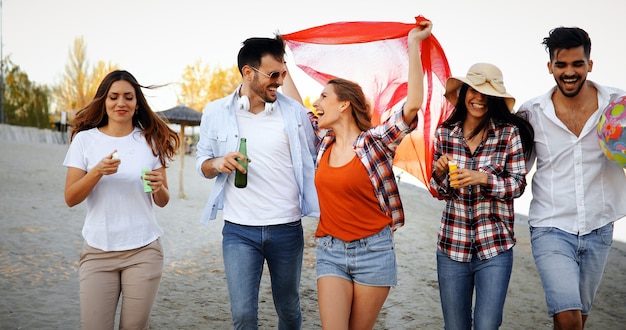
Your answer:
[79,239,163,330]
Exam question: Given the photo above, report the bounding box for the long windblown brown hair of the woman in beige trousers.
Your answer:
[70,70,180,167]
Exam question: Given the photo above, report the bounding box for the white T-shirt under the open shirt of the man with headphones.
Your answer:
[222,104,301,226]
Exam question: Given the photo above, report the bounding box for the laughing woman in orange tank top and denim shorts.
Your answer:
[283,21,432,329]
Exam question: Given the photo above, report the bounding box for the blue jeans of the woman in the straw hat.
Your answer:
[437,249,513,330]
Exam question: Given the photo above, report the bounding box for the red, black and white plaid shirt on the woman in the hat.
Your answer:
[430,121,527,262]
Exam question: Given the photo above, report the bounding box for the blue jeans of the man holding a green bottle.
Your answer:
[222,220,304,330]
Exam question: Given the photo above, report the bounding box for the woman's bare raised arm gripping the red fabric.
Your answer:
[404,21,433,124]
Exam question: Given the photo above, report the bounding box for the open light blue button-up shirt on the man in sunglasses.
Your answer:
[196,89,319,225]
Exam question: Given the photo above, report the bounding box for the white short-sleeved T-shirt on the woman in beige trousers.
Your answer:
[63,128,163,251]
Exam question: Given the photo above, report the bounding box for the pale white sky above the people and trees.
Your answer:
[0,0,626,111]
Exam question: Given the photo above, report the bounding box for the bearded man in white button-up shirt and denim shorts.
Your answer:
[518,27,626,329]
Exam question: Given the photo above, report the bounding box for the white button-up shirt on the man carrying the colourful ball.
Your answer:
[518,83,626,235]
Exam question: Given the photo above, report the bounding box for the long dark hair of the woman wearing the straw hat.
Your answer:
[441,84,535,158]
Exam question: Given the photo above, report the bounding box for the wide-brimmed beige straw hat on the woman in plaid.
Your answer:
[444,63,515,111]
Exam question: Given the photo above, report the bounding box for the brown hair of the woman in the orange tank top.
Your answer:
[326,78,372,131]
